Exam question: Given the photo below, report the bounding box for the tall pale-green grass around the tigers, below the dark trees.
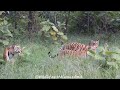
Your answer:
[0,35,120,79]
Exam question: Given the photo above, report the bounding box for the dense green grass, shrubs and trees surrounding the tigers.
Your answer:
[0,11,120,79]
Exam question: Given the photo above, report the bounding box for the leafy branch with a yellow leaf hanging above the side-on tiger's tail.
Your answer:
[39,20,68,43]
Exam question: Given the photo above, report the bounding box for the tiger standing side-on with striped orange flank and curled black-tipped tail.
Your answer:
[48,40,99,58]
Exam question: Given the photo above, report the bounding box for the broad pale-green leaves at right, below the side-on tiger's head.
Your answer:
[88,45,120,69]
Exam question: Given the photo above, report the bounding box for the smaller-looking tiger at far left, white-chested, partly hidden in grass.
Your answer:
[3,45,22,61]
